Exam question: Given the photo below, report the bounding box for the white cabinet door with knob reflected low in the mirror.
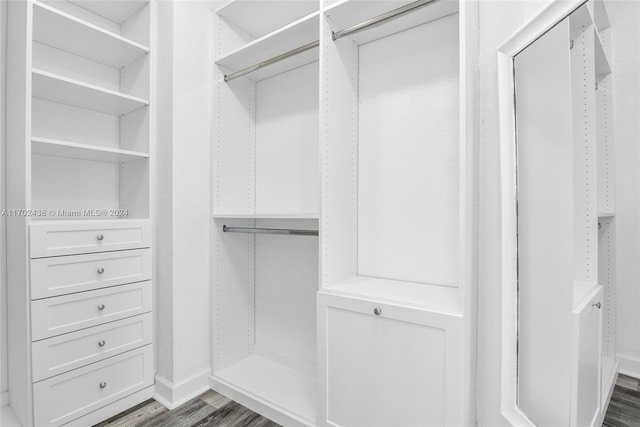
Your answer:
[571,286,602,427]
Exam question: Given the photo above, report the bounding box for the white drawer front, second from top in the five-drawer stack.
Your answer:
[31,249,151,299]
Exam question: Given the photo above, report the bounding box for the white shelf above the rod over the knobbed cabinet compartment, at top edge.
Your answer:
[325,0,459,45]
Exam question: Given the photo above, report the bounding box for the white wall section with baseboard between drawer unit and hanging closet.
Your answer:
[154,1,211,407]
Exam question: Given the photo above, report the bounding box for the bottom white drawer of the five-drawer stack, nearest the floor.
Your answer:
[33,345,153,427]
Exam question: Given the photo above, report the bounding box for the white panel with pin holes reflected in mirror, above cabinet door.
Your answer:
[570,21,598,286]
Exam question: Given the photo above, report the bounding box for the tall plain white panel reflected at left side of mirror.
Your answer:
[514,19,574,425]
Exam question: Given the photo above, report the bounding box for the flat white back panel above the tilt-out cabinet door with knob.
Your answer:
[358,14,460,286]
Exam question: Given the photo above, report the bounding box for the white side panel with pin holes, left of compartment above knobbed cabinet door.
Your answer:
[320,14,358,286]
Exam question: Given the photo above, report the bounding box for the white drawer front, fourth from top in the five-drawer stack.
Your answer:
[31,313,153,382]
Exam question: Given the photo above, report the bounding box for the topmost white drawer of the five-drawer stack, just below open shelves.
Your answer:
[30,219,151,258]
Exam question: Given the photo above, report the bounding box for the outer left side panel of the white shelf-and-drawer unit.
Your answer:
[6,1,33,425]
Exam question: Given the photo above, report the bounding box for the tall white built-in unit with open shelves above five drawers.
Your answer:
[7,0,155,426]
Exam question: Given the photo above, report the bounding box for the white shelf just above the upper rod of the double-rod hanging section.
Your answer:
[215,12,320,80]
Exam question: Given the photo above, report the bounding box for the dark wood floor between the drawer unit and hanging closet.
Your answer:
[95,390,278,427]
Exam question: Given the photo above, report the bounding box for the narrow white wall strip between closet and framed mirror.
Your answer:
[476,0,548,427]
